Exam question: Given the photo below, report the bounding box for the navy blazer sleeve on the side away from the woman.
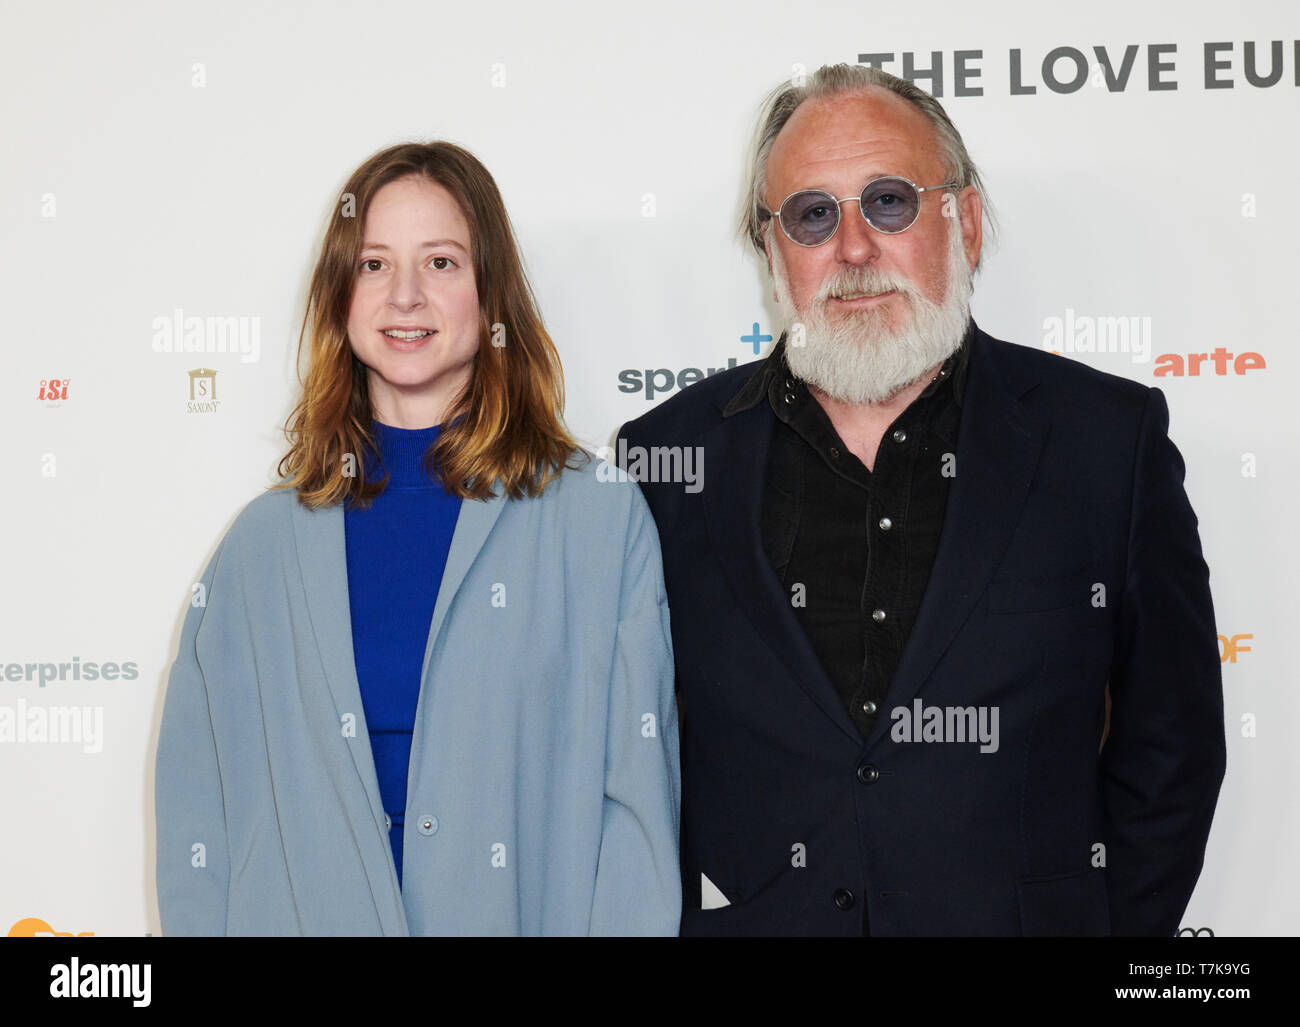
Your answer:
[1101,389,1226,937]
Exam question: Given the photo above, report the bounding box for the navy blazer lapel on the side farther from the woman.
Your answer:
[870,329,1048,742]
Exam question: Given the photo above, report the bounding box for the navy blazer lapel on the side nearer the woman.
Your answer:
[705,395,862,742]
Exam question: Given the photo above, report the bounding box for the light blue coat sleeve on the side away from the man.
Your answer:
[153,542,230,935]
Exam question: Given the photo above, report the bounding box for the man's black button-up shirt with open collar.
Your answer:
[725,324,974,738]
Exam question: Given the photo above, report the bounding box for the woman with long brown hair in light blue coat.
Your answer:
[156,143,681,935]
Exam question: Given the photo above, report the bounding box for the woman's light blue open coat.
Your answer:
[156,460,681,935]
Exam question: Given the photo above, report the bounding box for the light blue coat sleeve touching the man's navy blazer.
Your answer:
[590,485,681,935]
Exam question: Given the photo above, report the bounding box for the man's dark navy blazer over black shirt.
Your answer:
[616,326,1226,936]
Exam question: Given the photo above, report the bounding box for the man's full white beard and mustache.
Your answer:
[768,215,974,403]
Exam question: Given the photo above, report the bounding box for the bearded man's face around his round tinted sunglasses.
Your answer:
[766,87,983,403]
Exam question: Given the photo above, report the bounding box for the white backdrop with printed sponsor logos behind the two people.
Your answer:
[0,0,1300,935]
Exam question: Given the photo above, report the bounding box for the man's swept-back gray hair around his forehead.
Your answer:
[740,64,997,270]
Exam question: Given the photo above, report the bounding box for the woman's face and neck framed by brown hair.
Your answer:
[347,176,480,428]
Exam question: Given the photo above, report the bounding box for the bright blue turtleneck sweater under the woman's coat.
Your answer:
[343,421,460,884]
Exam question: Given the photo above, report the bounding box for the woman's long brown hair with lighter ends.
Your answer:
[273,142,581,508]
